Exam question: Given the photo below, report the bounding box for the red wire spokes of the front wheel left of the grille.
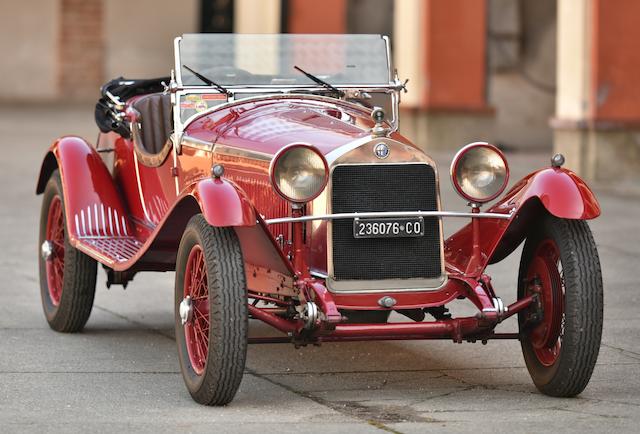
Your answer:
[184,245,209,375]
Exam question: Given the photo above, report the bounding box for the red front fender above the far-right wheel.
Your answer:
[444,168,600,274]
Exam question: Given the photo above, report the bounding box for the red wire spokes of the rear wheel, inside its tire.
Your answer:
[46,195,64,306]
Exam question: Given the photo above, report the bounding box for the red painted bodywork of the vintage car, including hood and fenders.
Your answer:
[37,96,600,343]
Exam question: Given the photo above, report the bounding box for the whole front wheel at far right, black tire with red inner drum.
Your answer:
[518,215,603,397]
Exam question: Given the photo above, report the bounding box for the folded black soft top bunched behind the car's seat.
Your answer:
[95,77,171,137]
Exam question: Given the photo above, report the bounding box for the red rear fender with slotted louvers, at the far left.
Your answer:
[36,136,133,245]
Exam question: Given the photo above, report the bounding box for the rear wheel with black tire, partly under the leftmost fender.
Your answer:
[38,170,97,333]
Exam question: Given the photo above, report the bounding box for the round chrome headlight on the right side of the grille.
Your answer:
[451,142,509,203]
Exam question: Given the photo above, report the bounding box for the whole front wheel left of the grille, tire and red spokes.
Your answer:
[175,214,249,405]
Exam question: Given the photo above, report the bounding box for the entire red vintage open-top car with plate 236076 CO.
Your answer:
[37,34,603,405]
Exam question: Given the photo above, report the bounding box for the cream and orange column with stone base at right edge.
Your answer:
[552,0,640,185]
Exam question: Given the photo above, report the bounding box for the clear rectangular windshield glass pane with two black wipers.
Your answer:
[176,33,391,87]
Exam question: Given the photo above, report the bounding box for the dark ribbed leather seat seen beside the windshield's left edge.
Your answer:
[133,93,173,155]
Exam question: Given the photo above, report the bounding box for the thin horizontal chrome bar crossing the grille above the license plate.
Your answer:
[264,211,512,225]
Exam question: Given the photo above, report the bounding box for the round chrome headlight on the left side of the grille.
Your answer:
[269,143,329,203]
